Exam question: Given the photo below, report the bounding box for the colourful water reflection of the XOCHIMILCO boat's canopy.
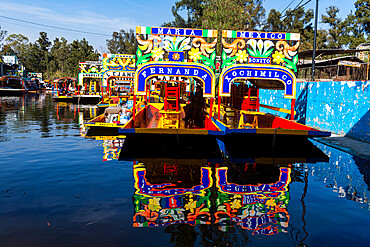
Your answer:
[214,164,291,235]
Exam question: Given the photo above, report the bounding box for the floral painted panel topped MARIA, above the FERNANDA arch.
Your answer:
[136,26,217,69]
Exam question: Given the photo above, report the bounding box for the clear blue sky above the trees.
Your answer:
[0,0,355,53]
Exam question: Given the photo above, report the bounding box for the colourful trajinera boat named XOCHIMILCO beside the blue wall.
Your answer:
[213,30,330,150]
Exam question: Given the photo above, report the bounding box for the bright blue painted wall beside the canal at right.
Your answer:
[260,81,370,143]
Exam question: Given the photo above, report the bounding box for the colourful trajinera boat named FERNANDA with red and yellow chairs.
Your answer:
[87,27,221,138]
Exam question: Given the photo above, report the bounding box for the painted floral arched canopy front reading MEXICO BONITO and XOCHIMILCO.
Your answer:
[219,30,300,99]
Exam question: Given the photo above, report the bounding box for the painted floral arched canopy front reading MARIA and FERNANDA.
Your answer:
[134,26,218,97]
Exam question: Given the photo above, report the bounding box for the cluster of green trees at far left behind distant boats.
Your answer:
[3,32,100,79]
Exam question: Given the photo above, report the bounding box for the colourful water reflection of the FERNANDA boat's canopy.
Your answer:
[133,160,213,227]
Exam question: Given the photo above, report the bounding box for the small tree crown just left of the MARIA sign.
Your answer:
[107,29,136,54]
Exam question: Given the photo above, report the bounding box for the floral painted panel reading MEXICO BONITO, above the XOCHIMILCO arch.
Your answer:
[221,30,300,72]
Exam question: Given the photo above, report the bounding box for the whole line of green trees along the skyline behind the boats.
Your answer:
[0,0,370,78]
